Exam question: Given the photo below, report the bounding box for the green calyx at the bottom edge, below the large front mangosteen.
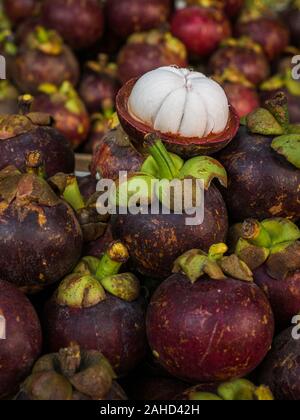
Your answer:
[189,379,274,401]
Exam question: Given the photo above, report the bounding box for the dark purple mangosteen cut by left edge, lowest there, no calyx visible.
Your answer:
[0,278,42,399]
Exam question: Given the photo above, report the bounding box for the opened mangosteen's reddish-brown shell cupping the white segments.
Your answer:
[116,79,240,158]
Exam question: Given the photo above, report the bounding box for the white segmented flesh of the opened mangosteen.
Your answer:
[128,66,229,138]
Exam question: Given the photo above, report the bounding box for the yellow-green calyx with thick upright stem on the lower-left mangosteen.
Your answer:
[56,241,140,308]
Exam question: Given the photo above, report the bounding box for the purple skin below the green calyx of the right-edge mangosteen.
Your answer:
[254,266,300,330]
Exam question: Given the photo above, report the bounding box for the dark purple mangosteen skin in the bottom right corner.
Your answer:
[259,327,300,401]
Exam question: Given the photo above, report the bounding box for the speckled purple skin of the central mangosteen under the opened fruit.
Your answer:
[112,186,228,279]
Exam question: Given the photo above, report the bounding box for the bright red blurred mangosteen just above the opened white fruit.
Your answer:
[171,6,231,57]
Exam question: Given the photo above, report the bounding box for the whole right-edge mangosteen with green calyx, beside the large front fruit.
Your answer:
[231,218,300,330]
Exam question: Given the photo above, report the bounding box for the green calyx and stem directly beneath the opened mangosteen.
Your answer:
[111,134,228,207]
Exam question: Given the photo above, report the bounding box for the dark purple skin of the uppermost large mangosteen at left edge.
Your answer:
[0,127,75,177]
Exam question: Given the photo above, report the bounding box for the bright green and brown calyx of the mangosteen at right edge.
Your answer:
[231,218,300,280]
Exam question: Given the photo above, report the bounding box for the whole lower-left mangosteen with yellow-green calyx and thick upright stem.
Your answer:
[45,241,147,375]
